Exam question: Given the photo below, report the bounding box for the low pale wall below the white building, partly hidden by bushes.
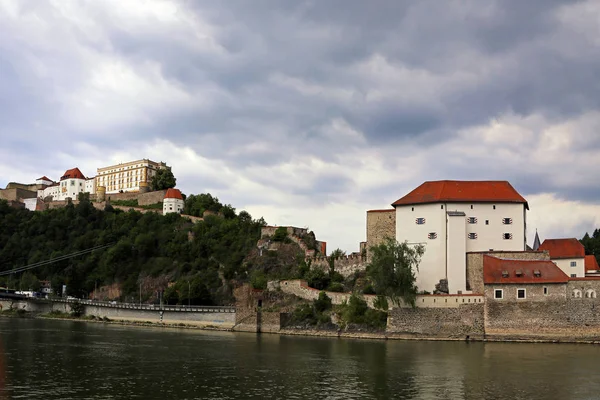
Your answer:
[274,279,484,309]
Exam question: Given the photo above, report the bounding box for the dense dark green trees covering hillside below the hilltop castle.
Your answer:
[0,195,264,304]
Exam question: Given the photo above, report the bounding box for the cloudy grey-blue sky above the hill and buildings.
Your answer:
[0,0,600,253]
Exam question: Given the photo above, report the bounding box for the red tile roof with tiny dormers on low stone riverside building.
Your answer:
[483,256,569,284]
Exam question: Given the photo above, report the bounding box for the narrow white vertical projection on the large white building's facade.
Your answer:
[446,215,468,294]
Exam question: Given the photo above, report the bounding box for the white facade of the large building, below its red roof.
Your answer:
[396,202,526,294]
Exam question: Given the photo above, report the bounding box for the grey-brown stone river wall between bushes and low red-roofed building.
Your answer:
[386,303,484,338]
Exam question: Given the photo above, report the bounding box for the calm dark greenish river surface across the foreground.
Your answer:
[0,318,600,399]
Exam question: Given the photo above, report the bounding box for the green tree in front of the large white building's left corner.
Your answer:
[367,238,425,307]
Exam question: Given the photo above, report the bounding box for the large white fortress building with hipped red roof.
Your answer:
[392,181,529,294]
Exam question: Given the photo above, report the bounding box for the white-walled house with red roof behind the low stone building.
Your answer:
[539,238,586,278]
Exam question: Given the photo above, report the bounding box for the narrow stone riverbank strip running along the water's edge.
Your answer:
[0,311,600,345]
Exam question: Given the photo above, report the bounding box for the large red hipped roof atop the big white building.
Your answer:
[392,181,529,210]
